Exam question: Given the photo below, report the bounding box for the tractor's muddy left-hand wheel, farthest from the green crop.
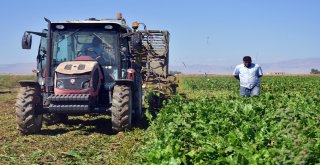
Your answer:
[15,86,42,134]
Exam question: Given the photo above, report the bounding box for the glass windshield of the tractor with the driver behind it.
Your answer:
[53,28,119,66]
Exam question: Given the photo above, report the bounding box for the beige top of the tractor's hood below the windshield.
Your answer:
[56,61,98,74]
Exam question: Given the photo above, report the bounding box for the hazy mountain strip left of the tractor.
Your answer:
[0,63,37,74]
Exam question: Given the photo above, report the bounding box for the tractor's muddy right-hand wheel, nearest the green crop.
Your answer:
[111,85,132,132]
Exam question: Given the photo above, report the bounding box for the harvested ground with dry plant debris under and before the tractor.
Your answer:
[0,89,145,164]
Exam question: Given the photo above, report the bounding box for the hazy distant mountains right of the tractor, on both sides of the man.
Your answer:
[170,58,320,74]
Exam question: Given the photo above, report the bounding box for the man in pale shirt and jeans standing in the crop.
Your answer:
[233,56,263,97]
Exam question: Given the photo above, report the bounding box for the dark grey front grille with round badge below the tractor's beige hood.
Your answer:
[56,72,91,90]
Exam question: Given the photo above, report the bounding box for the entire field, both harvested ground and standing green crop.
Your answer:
[0,76,320,164]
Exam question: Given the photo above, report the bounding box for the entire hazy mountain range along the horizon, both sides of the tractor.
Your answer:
[0,58,320,74]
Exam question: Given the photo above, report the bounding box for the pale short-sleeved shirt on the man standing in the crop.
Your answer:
[233,63,263,89]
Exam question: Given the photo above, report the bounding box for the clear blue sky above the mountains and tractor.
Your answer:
[0,0,320,66]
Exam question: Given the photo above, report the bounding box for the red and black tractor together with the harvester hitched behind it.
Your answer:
[16,13,176,135]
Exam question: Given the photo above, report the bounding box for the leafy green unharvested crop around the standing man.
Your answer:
[138,77,320,164]
